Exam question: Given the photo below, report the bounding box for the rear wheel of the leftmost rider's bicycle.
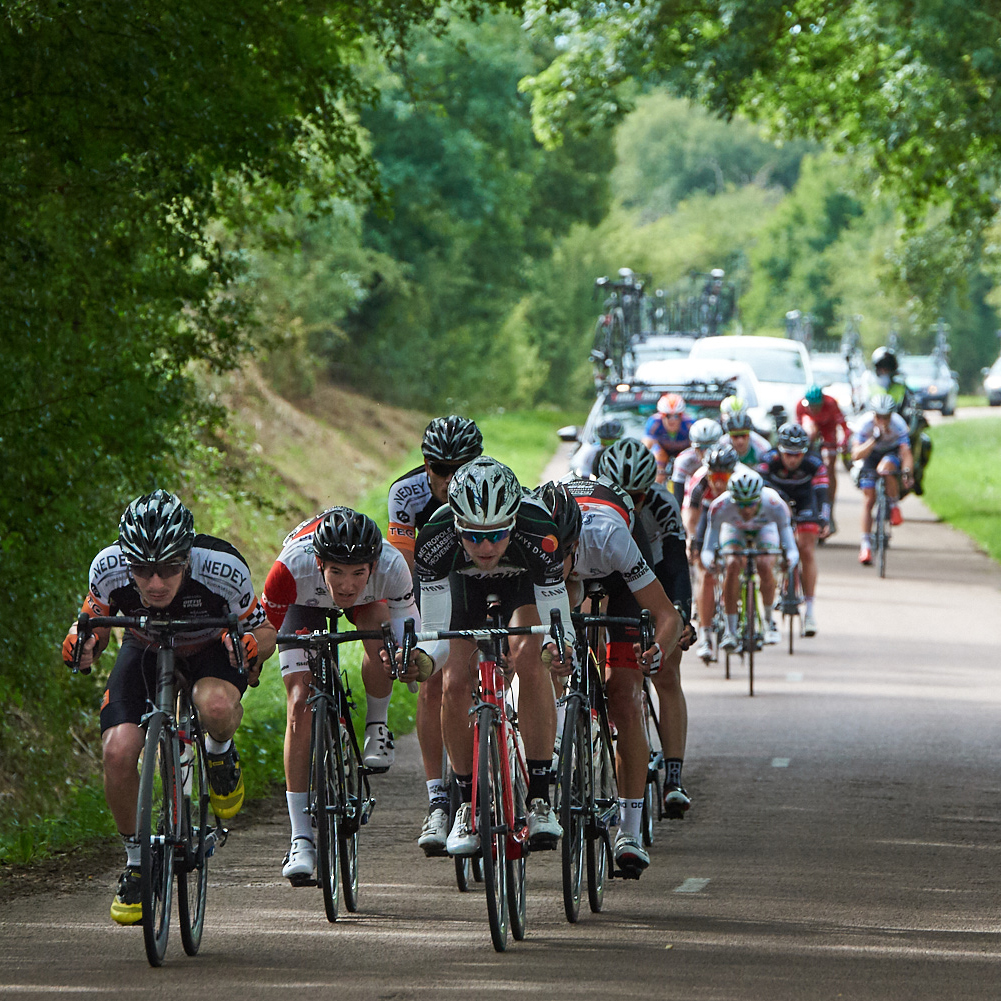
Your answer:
[177,693,213,956]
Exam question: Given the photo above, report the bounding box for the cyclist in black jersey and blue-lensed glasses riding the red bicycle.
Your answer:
[414,455,574,855]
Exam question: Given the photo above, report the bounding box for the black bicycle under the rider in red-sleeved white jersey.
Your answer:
[278,609,394,921]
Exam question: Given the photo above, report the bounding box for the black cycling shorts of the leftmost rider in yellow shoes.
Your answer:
[101,637,247,734]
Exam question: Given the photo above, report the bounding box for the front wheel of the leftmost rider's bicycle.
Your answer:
[138,712,178,966]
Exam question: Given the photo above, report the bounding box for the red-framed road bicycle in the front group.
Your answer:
[404,595,564,952]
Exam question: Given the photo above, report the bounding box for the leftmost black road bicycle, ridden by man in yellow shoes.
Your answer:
[73,613,246,966]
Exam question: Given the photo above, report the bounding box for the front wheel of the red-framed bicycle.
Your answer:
[475,707,509,952]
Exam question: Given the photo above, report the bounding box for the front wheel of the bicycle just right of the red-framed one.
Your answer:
[557,697,591,924]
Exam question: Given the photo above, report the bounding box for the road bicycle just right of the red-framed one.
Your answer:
[556,582,663,923]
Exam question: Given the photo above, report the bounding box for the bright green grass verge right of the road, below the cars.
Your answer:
[924,417,1001,561]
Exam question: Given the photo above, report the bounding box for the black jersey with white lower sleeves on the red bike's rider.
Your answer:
[413,497,574,668]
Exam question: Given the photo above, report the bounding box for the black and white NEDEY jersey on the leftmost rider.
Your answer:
[83,536,265,654]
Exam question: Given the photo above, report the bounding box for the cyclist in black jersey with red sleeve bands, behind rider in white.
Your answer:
[759,423,831,636]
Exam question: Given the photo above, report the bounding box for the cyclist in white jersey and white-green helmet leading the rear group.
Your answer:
[702,469,800,650]
